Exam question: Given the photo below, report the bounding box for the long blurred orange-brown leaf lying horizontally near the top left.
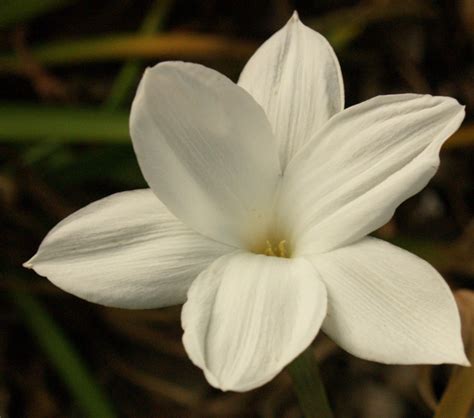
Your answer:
[0,32,258,72]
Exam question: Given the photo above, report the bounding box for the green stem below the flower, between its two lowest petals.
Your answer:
[287,347,334,418]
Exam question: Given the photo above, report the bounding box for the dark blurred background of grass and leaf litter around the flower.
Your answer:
[0,0,474,418]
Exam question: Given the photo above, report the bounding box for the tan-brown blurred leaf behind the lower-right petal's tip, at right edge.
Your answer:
[434,290,474,418]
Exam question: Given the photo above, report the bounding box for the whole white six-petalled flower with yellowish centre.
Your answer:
[25,14,468,391]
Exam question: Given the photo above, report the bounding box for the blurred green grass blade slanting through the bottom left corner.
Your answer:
[10,291,116,418]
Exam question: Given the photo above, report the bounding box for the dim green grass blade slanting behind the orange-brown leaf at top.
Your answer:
[104,0,173,110]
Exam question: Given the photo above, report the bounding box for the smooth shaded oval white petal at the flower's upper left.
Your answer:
[130,62,280,246]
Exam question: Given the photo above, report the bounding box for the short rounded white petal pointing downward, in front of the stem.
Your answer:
[182,252,326,392]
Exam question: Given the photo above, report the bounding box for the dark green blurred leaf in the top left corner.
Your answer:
[0,0,75,29]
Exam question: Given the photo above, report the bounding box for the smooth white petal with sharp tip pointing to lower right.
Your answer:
[310,238,468,365]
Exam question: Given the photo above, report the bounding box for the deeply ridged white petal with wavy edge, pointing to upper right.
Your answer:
[279,94,464,254]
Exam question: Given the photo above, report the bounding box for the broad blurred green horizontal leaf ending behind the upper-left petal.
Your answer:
[0,104,130,143]
